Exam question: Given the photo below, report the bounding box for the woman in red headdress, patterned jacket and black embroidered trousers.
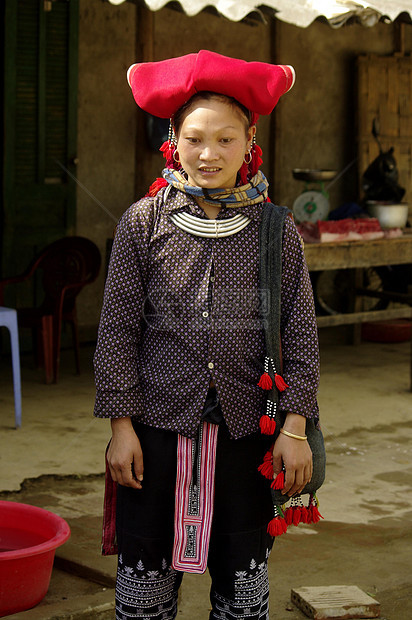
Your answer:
[95,50,319,620]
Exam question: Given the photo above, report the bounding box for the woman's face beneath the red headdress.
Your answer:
[177,99,256,189]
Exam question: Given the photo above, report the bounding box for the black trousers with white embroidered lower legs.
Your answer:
[116,422,272,620]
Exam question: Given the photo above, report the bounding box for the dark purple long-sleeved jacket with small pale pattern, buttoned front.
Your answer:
[94,189,319,438]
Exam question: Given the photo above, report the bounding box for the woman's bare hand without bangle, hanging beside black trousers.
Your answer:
[107,417,143,489]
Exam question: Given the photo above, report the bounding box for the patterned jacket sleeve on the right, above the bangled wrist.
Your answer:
[280,217,320,419]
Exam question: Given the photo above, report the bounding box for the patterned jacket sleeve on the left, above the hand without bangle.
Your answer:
[94,198,153,418]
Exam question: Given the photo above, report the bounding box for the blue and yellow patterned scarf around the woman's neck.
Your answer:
[162,168,269,207]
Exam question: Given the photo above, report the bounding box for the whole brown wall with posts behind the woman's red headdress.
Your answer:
[77,0,412,331]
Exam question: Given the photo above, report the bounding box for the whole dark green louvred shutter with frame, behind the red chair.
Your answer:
[3,0,79,273]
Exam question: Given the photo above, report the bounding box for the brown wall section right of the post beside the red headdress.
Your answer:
[275,21,412,209]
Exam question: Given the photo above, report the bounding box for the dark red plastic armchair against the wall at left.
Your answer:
[0,237,101,383]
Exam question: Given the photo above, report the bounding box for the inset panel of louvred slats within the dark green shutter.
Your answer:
[15,0,69,185]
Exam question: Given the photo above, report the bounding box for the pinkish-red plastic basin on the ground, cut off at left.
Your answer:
[0,501,70,617]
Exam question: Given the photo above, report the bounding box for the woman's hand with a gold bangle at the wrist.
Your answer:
[273,413,313,497]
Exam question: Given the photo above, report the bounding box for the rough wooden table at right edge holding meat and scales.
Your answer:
[305,234,412,391]
